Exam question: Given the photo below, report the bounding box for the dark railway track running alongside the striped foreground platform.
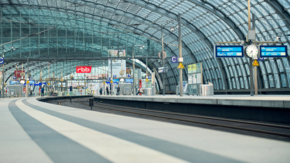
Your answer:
[59,100,290,138]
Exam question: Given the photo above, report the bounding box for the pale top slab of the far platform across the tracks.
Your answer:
[94,95,290,108]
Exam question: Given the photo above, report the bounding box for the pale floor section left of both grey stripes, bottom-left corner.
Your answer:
[0,98,53,163]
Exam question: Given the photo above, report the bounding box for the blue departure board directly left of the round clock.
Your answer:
[215,46,244,58]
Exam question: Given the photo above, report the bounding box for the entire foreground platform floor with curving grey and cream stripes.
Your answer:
[0,98,290,163]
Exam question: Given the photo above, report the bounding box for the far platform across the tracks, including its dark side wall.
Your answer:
[94,95,290,125]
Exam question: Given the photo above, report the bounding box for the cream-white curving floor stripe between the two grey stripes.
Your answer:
[16,100,186,163]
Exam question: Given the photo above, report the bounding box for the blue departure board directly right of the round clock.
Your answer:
[260,45,288,57]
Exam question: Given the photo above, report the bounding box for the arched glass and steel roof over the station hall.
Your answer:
[0,0,290,92]
